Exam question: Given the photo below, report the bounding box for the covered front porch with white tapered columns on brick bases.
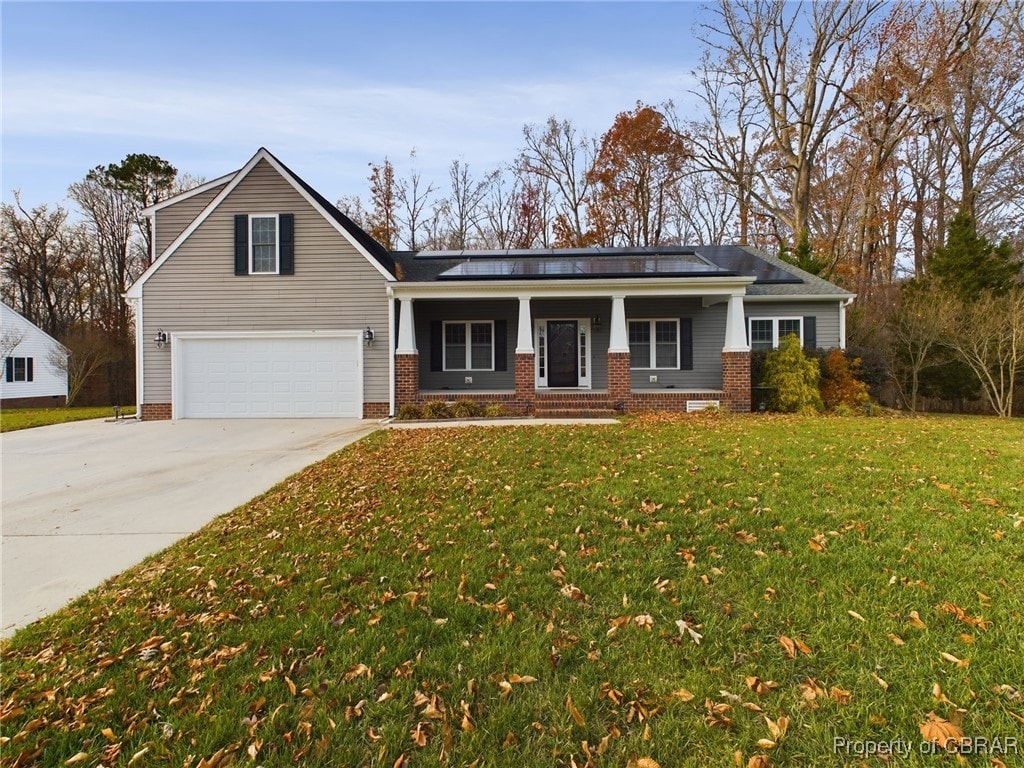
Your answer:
[392,278,751,416]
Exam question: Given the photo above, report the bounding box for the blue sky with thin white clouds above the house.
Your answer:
[0,0,700,210]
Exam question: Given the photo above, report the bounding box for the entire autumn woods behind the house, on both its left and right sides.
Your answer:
[2,0,1024,411]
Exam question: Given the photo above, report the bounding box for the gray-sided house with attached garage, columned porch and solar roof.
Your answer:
[127,148,853,419]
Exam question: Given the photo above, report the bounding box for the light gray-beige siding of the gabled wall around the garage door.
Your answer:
[142,161,391,403]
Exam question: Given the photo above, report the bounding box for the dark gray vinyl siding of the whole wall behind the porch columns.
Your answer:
[413,298,726,393]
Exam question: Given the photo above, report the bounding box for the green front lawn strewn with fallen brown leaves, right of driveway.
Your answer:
[0,415,1024,768]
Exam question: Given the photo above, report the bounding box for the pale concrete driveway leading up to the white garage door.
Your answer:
[0,419,378,637]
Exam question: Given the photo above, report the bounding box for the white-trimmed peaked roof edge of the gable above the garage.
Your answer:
[125,147,395,299]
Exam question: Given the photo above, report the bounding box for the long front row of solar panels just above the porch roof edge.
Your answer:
[438,255,733,280]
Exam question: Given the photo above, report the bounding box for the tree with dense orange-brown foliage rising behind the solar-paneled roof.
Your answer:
[587,101,692,246]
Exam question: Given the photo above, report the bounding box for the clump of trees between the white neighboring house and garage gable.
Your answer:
[0,155,193,403]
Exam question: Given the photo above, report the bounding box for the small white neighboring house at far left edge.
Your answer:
[0,302,68,408]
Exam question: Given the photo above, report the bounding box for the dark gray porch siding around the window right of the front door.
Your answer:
[626,297,728,391]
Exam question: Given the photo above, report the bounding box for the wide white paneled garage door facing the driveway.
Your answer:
[174,334,362,419]
